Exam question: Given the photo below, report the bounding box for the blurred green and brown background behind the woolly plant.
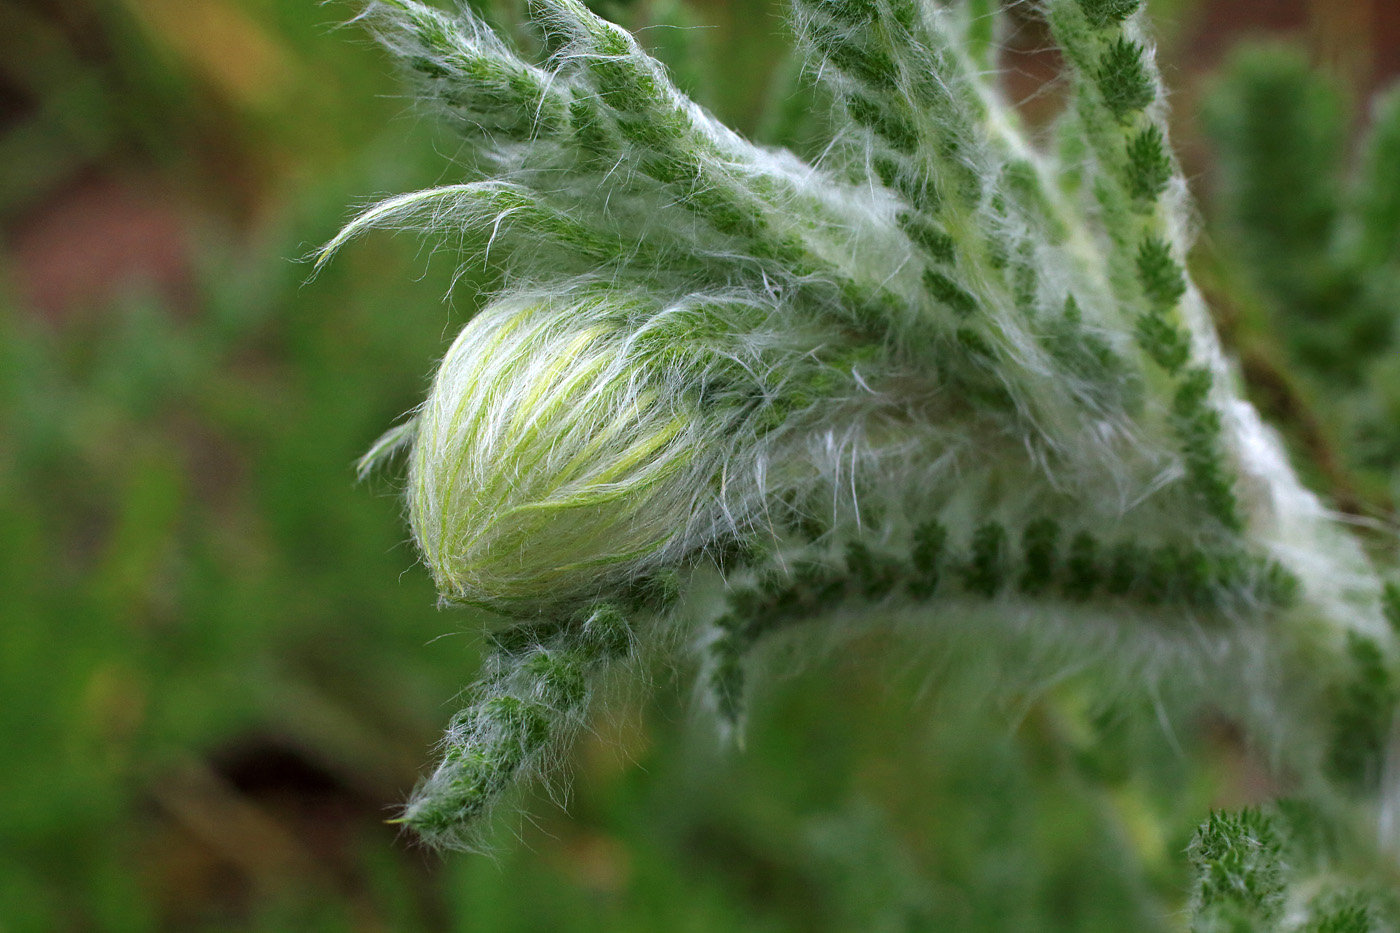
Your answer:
[0,0,1400,932]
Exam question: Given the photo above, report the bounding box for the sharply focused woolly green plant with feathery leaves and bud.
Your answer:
[318,0,1396,913]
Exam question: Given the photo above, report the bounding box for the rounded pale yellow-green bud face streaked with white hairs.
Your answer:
[409,297,722,612]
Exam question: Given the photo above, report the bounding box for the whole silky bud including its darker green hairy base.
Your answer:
[409,287,873,615]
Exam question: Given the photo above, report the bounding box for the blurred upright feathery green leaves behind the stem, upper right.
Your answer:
[1205,46,1400,523]
